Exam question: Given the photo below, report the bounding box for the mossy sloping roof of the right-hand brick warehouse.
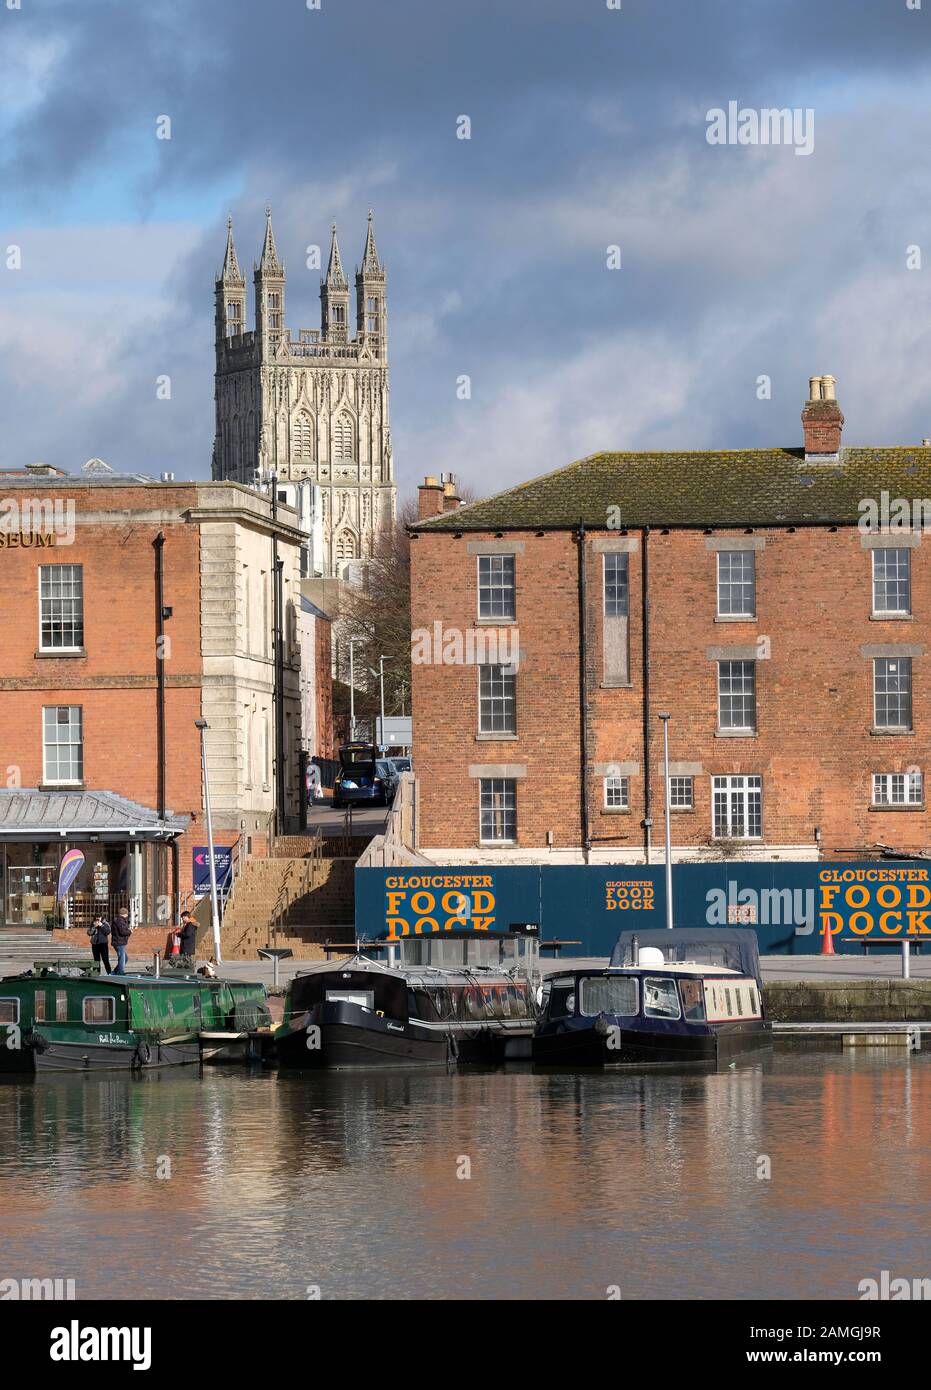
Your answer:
[415,445,931,531]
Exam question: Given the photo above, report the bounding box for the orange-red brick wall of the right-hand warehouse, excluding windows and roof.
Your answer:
[411,527,931,853]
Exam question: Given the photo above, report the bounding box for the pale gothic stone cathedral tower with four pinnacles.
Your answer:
[213,209,396,574]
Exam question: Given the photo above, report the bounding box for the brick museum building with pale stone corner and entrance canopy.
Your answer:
[0,460,331,926]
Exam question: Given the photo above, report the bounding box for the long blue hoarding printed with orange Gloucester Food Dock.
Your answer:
[356,859,931,956]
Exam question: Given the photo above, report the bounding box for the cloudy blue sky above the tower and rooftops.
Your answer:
[0,0,931,493]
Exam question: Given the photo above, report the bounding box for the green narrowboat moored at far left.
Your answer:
[0,967,271,1073]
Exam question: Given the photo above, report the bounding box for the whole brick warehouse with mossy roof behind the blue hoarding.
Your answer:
[411,377,931,863]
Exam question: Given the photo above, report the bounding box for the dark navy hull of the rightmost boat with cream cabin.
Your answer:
[531,1020,773,1069]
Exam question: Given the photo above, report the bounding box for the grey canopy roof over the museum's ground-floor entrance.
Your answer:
[0,788,189,838]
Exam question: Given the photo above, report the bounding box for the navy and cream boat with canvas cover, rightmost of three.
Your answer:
[532,929,773,1068]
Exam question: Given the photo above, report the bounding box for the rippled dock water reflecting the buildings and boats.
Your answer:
[0,1048,931,1300]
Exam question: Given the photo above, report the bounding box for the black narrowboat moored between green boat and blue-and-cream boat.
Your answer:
[275,931,539,1069]
